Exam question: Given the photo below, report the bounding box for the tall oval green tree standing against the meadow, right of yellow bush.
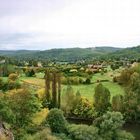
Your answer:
[94,83,110,114]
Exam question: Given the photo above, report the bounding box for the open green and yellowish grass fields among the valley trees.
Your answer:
[20,71,124,101]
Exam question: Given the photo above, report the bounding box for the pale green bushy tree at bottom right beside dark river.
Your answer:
[93,112,134,140]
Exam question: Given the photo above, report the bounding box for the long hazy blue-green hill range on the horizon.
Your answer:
[0,46,121,61]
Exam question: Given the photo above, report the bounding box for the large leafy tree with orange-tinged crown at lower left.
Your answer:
[0,89,41,138]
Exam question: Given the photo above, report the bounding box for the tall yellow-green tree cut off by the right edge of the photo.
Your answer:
[123,69,140,121]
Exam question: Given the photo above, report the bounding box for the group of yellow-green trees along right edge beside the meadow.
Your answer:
[112,65,140,121]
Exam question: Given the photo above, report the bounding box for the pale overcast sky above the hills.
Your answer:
[0,0,140,50]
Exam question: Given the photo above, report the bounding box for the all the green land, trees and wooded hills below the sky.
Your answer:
[0,47,140,140]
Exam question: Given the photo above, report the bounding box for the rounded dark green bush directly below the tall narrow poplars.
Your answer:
[46,109,66,133]
